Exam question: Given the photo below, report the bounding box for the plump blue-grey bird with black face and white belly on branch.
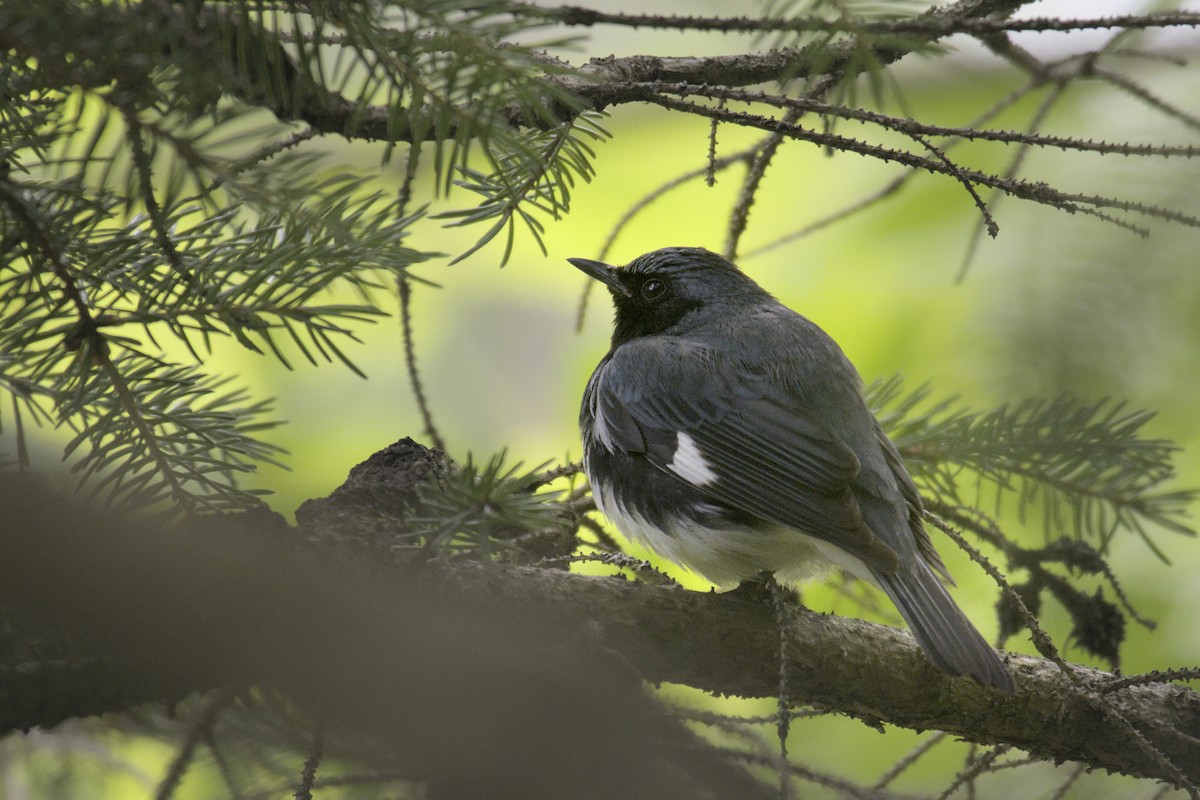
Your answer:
[569,247,1014,692]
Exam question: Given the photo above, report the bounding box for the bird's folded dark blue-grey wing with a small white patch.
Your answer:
[589,338,899,572]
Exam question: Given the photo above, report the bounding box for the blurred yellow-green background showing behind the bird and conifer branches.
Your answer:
[2,4,1200,796]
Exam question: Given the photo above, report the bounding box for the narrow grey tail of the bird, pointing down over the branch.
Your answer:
[875,561,1016,694]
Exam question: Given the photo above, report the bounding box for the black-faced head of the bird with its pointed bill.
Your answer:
[566,247,770,347]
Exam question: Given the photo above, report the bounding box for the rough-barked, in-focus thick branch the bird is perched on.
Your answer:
[482,571,1200,783]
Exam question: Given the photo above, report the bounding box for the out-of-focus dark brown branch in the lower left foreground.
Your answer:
[0,479,770,800]
